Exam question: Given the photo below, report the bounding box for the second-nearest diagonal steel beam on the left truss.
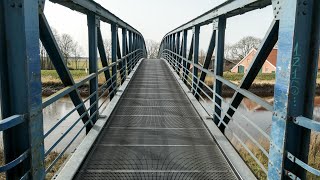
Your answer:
[97,27,114,99]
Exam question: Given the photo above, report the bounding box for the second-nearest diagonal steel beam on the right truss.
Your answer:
[195,30,216,100]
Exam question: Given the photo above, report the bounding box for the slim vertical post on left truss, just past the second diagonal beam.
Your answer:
[111,23,118,91]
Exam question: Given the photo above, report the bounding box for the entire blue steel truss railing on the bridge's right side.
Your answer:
[159,0,320,179]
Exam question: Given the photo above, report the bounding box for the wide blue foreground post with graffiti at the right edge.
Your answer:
[268,0,320,179]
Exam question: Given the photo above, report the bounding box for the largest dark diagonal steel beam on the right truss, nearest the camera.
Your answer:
[219,20,279,132]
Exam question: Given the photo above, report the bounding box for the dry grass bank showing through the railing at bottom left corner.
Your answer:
[0,151,68,180]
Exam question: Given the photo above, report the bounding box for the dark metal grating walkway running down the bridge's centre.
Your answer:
[76,60,237,180]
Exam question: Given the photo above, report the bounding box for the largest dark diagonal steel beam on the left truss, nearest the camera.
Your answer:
[39,12,92,133]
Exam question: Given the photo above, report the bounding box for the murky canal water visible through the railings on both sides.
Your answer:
[0,97,320,153]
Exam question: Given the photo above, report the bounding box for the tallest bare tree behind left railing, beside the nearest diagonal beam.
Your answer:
[58,34,75,64]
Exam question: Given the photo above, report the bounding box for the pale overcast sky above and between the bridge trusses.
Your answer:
[45,0,272,55]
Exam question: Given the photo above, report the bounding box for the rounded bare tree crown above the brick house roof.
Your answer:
[227,36,261,60]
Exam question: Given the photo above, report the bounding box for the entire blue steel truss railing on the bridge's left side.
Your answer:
[0,0,147,179]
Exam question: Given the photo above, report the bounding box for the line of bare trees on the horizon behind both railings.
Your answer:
[40,29,261,69]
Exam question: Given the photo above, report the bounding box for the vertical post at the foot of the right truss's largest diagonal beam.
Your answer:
[214,16,226,124]
